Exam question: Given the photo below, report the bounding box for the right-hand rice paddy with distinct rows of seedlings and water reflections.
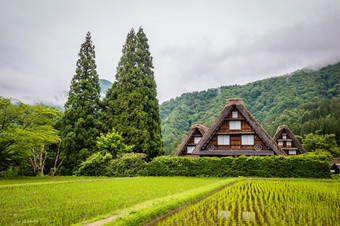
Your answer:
[152,179,340,225]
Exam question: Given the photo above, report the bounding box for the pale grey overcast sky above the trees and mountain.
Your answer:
[0,0,340,105]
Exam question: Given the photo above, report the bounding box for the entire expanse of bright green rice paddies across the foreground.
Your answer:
[0,177,340,225]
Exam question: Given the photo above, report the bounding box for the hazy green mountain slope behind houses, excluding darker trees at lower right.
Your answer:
[160,63,340,154]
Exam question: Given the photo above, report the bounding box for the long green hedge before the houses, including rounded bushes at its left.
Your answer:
[76,153,332,178]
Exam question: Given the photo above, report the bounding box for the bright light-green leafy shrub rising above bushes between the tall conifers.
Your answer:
[97,129,133,158]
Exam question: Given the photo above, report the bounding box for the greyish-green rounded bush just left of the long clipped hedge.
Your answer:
[105,153,146,177]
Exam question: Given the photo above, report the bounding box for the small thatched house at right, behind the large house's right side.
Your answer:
[273,125,307,155]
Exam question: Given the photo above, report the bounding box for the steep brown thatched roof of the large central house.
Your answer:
[193,98,287,156]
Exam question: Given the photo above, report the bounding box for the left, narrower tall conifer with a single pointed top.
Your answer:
[62,32,100,174]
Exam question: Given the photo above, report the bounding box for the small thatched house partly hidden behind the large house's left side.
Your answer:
[173,124,208,157]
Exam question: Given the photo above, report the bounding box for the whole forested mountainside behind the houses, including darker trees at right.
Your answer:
[160,63,340,154]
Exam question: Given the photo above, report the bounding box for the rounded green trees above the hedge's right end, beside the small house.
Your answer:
[302,133,340,157]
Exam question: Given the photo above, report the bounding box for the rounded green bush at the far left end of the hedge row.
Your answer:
[75,152,112,176]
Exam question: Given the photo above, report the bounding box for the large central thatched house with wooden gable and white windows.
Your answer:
[192,99,287,156]
